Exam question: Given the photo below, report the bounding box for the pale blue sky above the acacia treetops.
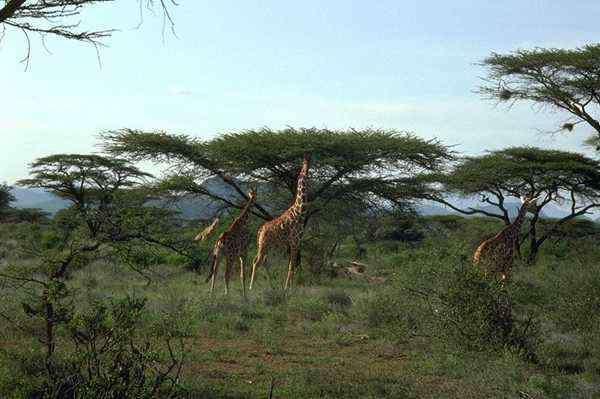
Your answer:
[0,0,600,182]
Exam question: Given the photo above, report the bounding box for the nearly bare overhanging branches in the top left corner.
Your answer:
[0,0,177,65]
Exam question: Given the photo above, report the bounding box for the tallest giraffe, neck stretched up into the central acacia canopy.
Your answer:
[250,154,310,289]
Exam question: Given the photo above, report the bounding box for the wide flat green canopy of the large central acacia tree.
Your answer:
[103,128,452,222]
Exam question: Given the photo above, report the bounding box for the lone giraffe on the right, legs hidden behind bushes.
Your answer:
[473,197,537,280]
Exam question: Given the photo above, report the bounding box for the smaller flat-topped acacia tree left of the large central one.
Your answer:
[18,154,200,267]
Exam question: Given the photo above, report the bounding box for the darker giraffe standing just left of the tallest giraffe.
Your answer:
[194,189,256,297]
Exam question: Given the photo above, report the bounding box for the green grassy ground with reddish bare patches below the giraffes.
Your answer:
[0,220,600,398]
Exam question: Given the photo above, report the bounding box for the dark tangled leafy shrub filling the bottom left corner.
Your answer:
[3,297,188,398]
